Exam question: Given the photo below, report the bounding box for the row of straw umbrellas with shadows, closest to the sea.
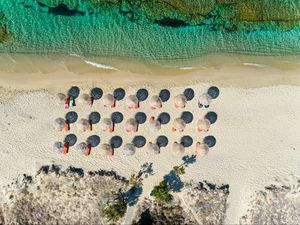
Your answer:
[57,86,220,110]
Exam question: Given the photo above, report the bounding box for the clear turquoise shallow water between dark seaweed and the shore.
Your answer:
[0,0,300,62]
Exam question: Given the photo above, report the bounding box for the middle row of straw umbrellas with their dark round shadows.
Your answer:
[53,111,218,132]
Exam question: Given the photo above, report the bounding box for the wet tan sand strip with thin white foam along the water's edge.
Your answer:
[0,54,300,90]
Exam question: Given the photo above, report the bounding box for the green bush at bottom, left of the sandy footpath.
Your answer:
[103,198,127,222]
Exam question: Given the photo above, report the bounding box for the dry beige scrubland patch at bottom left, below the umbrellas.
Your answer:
[0,166,127,224]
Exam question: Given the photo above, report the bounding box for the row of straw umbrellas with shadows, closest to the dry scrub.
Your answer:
[53,134,216,156]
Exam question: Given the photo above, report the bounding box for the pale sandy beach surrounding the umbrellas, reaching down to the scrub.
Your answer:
[0,55,300,224]
